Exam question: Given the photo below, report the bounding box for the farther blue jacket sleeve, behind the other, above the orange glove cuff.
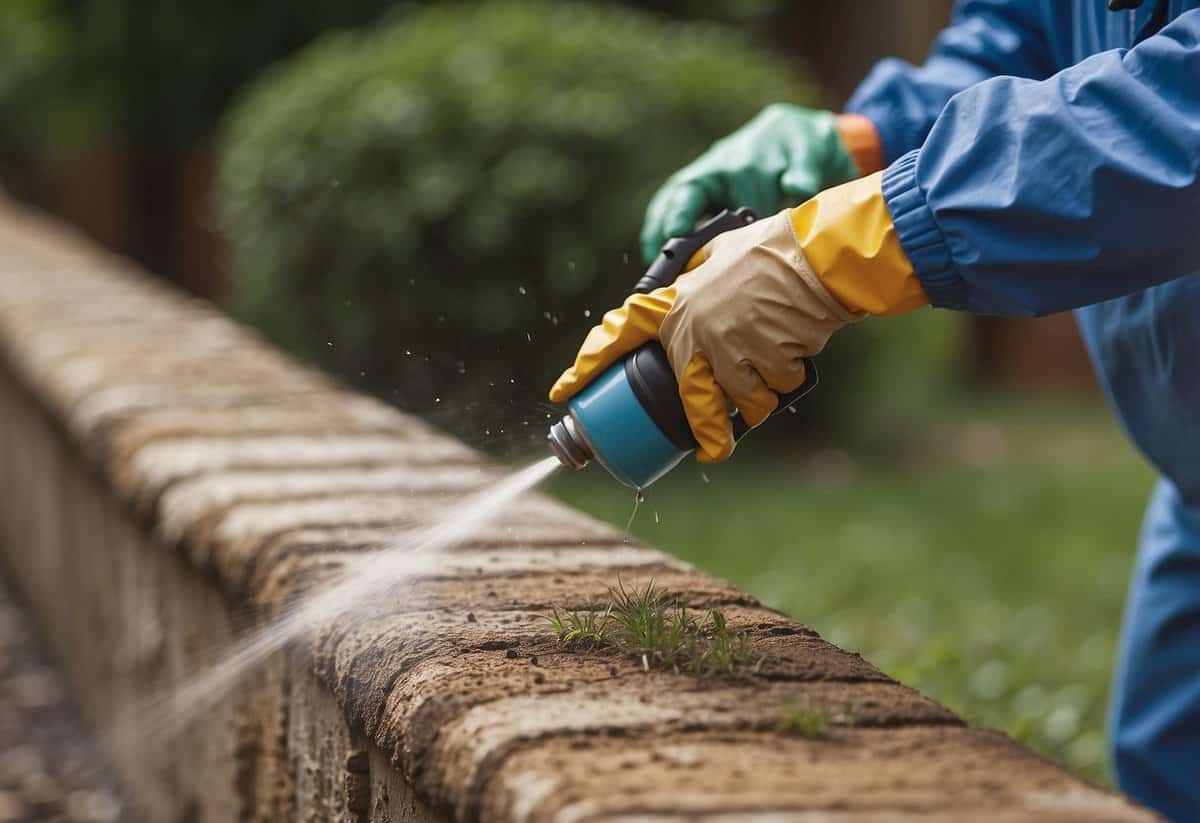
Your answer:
[846,0,1056,163]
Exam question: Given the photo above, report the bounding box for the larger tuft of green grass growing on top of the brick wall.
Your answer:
[545,578,761,677]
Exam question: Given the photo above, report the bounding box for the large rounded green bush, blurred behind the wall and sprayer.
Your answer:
[220,2,835,441]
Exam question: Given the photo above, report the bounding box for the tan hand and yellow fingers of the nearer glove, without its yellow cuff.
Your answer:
[550,211,854,462]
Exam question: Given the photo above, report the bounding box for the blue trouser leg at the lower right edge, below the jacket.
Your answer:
[1109,480,1200,821]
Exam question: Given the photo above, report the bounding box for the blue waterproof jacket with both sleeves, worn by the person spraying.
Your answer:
[847,0,1200,505]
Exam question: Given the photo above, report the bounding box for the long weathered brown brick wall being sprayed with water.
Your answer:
[0,196,1146,822]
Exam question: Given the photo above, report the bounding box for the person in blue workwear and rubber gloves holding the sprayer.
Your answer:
[551,0,1200,819]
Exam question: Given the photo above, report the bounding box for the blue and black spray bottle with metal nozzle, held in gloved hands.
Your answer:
[546,209,817,488]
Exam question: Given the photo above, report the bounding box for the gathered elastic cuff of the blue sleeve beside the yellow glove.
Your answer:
[882,149,967,311]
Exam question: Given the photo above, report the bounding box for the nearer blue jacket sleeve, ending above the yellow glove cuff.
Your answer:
[883,10,1200,316]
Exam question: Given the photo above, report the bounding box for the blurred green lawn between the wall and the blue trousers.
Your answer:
[550,401,1152,781]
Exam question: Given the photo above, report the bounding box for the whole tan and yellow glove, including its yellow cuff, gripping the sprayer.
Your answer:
[550,174,928,463]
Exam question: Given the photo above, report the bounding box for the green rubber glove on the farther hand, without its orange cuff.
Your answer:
[642,103,859,264]
